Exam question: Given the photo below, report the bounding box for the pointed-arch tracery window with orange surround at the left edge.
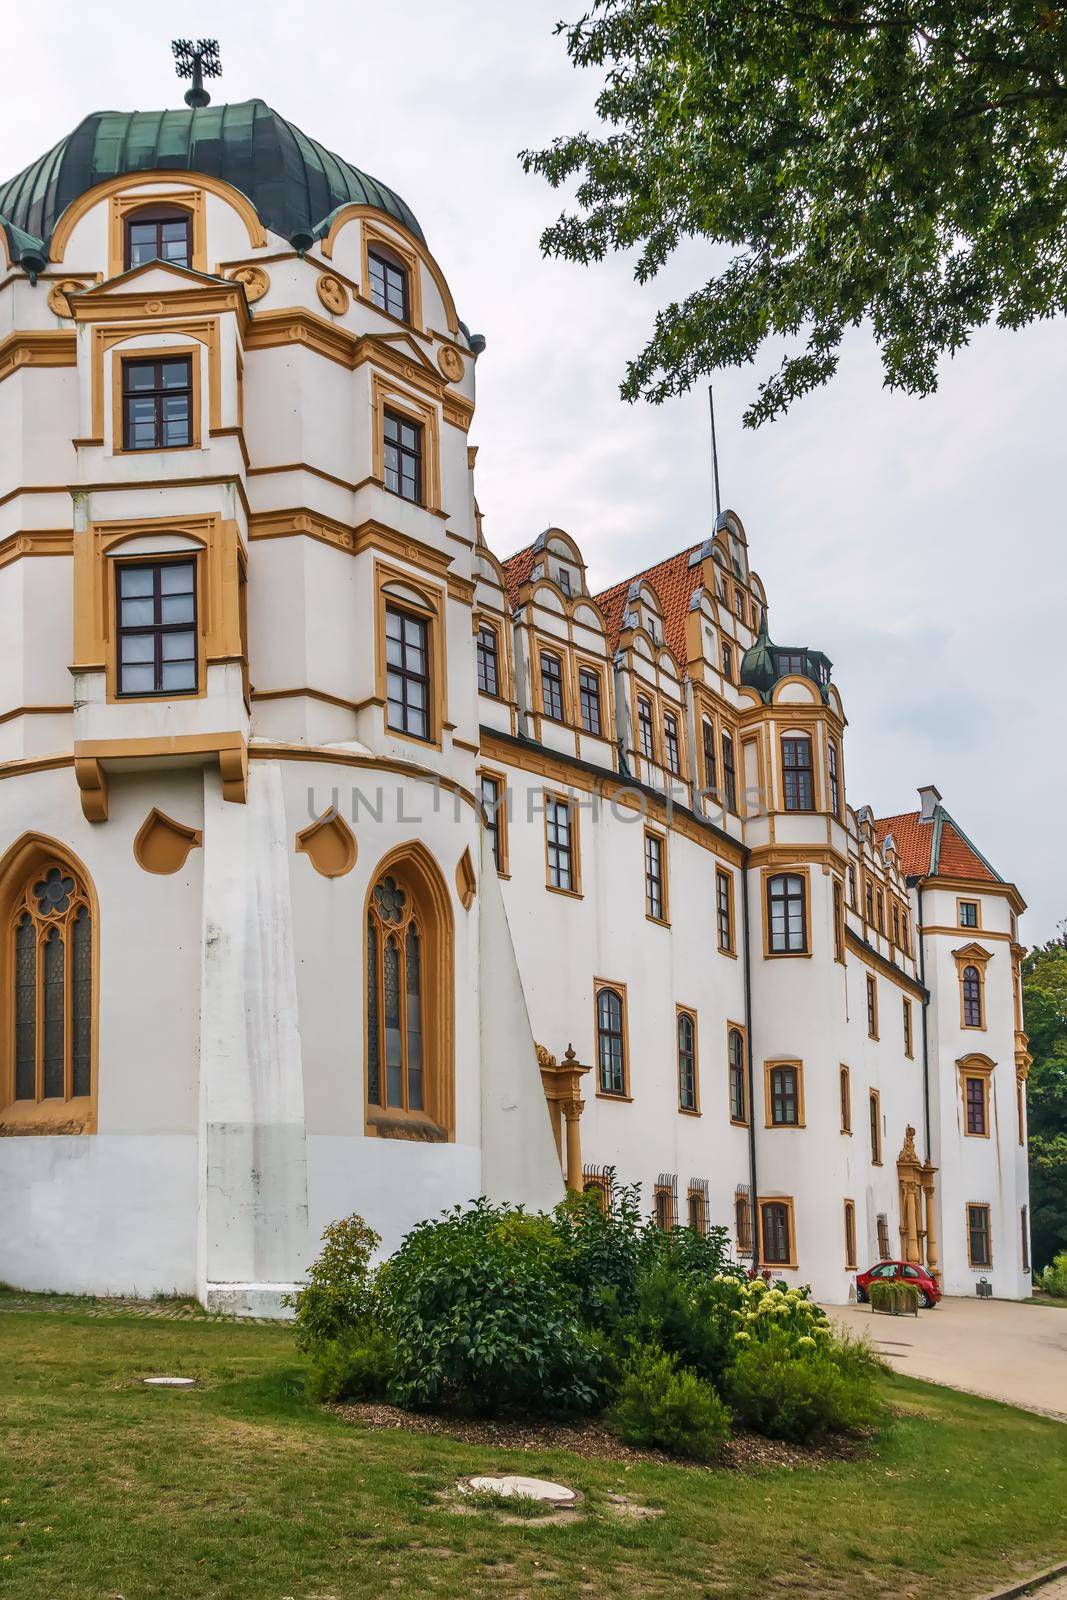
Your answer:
[3,845,94,1120]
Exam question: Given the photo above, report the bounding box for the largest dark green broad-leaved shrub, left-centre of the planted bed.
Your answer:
[378,1200,601,1414]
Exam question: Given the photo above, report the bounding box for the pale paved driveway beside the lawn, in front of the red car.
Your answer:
[825,1298,1067,1421]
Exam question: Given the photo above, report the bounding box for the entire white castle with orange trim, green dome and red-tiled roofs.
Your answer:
[0,101,1029,1314]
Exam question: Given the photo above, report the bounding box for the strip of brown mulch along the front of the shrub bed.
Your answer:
[328,1403,867,1472]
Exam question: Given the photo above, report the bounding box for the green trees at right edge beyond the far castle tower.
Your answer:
[1022,933,1067,1270]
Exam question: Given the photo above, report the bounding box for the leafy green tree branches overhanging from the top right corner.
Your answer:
[522,0,1067,427]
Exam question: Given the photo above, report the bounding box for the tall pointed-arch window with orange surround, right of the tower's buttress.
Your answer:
[366,846,453,1141]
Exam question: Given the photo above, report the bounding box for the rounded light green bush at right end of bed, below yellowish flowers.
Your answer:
[726,1331,885,1445]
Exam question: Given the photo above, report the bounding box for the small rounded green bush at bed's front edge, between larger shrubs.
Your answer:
[608,1344,729,1461]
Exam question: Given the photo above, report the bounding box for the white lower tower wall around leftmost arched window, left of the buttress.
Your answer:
[0,768,202,1294]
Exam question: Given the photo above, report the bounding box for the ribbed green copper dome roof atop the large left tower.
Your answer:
[0,99,422,258]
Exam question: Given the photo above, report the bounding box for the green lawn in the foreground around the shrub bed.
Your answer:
[0,1296,1067,1600]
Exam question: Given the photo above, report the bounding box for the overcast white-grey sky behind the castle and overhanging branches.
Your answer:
[8,0,1067,941]
